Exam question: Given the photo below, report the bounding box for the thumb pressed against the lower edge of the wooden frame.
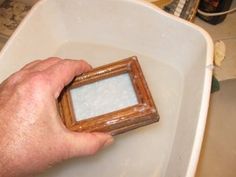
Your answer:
[64,132,113,157]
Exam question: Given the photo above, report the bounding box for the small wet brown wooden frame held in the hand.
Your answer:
[58,57,159,135]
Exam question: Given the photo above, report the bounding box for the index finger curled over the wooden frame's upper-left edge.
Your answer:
[45,59,91,98]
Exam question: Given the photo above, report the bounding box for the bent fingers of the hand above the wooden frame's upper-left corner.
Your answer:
[21,57,92,98]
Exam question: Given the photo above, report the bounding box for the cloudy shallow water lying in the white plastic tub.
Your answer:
[37,42,183,177]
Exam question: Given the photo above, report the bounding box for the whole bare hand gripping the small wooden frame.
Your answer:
[0,58,113,177]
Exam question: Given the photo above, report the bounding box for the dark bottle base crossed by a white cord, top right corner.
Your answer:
[197,0,232,25]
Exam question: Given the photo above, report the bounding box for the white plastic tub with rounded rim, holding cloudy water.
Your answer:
[0,0,213,177]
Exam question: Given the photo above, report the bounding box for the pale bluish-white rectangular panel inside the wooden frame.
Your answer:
[70,73,138,121]
